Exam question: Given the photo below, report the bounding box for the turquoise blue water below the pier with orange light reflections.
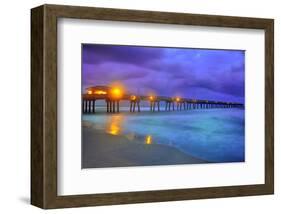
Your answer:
[82,108,245,162]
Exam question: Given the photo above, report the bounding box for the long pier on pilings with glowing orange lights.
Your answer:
[82,86,244,113]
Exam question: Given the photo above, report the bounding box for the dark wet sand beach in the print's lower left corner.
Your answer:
[82,122,207,168]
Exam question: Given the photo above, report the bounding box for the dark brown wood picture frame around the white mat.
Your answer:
[31,5,274,209]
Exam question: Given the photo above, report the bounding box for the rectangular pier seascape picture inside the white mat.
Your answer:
[81,44,245,169]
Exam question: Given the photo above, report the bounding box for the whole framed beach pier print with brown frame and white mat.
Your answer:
[31,5,274,208]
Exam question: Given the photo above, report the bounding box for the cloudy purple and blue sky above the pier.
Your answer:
[82,44,245,103]
